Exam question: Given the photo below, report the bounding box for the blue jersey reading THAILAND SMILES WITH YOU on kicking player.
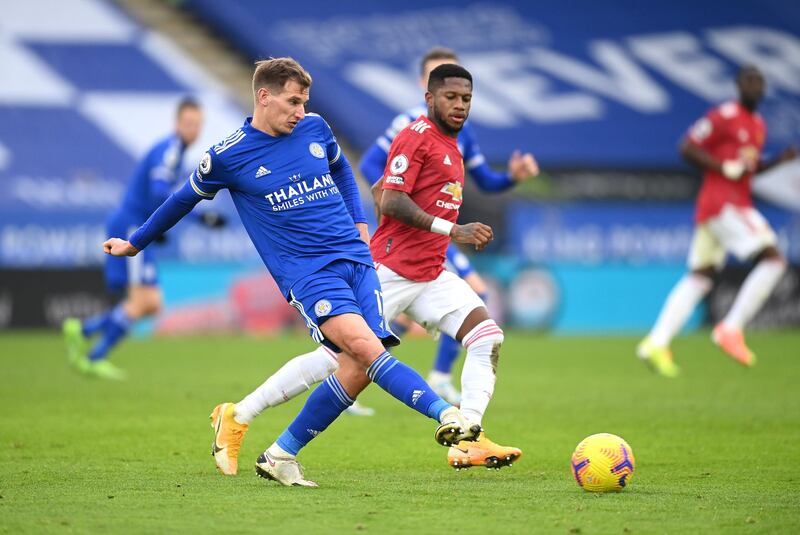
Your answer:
[189,113,372,297]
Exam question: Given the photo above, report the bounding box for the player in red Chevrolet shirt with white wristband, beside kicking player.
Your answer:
[370,63,522,468]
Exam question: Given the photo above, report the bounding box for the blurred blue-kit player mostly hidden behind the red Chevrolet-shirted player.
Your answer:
[359,47,539,404]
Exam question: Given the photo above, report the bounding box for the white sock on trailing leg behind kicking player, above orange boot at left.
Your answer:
[233,346,339,424]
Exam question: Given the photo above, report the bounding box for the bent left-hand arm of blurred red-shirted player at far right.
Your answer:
[680,109,753,180]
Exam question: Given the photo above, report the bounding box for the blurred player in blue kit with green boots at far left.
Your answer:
[63,97,208,380]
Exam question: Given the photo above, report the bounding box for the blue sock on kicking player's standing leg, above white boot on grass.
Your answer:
[276,375,353,455]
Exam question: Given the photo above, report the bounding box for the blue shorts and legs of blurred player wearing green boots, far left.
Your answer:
[63,218,162,380]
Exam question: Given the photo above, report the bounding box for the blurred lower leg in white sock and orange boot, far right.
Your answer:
[711,251,786,366]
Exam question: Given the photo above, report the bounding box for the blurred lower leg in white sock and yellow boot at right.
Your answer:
[636,272,712,378]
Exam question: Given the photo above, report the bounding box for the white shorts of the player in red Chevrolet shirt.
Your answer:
[377,264,486,338]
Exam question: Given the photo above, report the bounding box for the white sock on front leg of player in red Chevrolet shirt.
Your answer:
[461,320,503,424]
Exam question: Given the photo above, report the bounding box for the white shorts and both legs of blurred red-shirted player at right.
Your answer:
[637,206,786,377]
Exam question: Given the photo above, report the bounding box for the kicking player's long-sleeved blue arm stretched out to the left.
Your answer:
[103,150,227,256]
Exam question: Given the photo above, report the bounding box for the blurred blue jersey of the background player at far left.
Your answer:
[117,133,186,225]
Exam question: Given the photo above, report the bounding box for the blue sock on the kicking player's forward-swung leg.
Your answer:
[367,351,452,422]
